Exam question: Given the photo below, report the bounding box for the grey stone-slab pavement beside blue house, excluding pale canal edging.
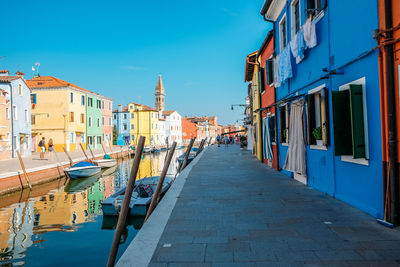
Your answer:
[149,145,400,267]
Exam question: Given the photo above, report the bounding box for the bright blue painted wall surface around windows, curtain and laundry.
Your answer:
[274,0,383,218]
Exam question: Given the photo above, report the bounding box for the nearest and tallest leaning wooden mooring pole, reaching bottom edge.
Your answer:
[107,136,146,267]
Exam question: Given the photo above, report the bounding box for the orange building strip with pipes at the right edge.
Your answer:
[376,0,400,226]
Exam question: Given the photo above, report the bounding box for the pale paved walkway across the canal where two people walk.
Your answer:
[0,146,121,178]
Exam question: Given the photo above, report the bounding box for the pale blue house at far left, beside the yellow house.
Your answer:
[0,71,32,158]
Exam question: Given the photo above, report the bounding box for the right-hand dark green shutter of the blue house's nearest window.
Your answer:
[350,84,365,159]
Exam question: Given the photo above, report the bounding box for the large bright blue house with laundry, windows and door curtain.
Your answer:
[261,0,384,218]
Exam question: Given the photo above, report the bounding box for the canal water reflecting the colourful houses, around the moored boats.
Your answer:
[0,150,183,266]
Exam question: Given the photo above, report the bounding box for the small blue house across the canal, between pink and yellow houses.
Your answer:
[113,105,130,146]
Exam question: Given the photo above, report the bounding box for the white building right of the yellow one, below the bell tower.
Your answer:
[162,110,182,144]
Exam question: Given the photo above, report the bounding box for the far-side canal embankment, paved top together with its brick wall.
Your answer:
[0,147,127,195]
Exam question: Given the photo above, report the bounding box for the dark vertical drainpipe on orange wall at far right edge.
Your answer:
[385,0,399,226]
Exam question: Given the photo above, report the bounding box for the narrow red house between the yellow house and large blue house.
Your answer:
[257,31,278,169]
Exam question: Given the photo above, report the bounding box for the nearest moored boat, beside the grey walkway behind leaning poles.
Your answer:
[101,176,173,216]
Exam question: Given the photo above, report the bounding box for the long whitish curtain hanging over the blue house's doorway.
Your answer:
[283,99,306,175]
